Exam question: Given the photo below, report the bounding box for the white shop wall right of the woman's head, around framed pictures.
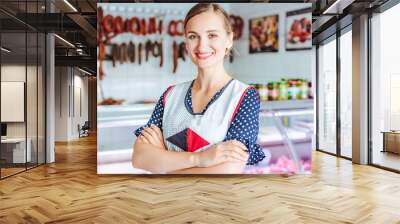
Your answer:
[229,3,312,83]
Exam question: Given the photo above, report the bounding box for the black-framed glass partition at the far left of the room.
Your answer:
[0,1,46,178]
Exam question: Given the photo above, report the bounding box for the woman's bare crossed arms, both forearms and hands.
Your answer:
[132,125,249,174]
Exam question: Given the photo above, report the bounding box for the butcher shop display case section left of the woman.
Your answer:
[97,104,155,174]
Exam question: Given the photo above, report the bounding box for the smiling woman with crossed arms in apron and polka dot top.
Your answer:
[132,3,265,174]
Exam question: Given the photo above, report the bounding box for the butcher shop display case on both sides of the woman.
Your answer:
[98,100,314,174]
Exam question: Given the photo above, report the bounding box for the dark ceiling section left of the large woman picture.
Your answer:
[0,0,97,74]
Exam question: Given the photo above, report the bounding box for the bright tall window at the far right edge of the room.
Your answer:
[370,4,400,170]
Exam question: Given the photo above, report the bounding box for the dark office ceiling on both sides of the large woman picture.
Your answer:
[0,0,394,73]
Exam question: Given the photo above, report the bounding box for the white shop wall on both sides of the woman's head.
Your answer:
[98,3,312,102]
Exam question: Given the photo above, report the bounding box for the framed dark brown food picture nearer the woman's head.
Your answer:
[249,15,279,54]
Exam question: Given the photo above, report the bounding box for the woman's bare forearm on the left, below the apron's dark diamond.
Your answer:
[132,141,198,173]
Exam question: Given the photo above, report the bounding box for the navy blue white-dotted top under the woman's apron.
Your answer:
[135,80,265,165]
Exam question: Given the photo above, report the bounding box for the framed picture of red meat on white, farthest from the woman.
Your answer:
[286,8,312,51]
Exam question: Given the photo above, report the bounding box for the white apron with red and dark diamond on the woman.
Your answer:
[162,79,250,152]
